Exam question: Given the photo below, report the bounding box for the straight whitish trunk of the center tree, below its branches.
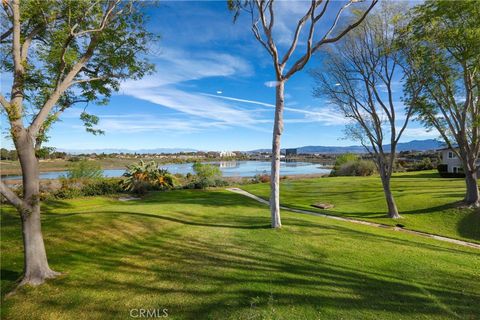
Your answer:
[270,81,285,228]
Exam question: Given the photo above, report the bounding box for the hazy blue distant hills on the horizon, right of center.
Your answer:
[250,139,444,154]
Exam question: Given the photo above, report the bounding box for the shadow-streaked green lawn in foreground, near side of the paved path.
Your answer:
[0,189,480,320]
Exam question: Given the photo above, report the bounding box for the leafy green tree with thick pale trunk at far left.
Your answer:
[0,0,153,285]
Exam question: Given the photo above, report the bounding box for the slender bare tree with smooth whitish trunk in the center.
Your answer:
[228,0,378,228]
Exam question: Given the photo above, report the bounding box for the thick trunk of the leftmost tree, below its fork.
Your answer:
[14,130,59,285]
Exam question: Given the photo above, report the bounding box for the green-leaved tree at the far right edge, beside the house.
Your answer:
[400,0,480,207]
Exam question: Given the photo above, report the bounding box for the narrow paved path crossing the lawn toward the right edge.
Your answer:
[227,188,480,249]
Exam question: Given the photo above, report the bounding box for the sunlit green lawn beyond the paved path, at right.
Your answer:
[241,171,480,243]
